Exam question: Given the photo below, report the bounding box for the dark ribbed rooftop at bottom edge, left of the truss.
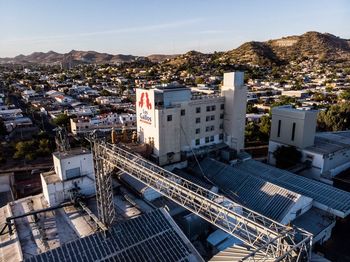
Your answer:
[25,209,203,262]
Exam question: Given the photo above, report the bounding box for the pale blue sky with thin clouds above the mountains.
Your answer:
[0,0,350,57]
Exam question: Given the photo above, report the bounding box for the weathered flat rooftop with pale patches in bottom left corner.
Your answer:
[0,194,85,262]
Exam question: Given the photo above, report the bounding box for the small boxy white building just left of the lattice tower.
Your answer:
[41,149,95,206]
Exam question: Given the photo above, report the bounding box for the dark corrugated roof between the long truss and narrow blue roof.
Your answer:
[197,158,301,222]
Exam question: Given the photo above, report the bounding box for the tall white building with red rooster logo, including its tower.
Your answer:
[136,72,247,165]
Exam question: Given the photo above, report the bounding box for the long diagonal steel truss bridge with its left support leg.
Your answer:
[93,142,312,261]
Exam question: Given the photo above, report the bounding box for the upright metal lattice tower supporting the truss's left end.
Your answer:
[92,140,115,227]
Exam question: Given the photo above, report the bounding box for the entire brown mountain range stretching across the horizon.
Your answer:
[0,32,350,66]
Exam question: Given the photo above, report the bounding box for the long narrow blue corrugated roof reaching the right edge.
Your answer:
[234,160,350,217]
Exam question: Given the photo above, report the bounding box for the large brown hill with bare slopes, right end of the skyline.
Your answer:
[221,32,350,65]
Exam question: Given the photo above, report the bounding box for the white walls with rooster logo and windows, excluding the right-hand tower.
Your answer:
[136,89,224,165]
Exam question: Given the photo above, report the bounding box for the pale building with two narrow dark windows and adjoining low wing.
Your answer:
[268,106,350,184]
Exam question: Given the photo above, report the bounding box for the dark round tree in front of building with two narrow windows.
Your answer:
[273,146,302,169]
